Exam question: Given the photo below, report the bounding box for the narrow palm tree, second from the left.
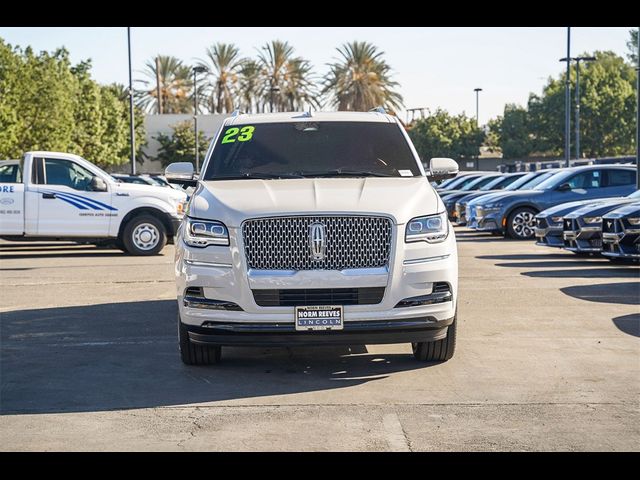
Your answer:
[200,43,243,113]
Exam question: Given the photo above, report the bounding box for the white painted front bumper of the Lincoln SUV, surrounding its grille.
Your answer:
[175,221,458,334]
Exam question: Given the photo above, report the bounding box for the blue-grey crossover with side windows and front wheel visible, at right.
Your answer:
[468,165,636,240]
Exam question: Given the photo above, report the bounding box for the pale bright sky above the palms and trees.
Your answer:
[0,27,633,124]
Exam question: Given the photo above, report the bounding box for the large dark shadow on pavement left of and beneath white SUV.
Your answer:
[0,300,435,415]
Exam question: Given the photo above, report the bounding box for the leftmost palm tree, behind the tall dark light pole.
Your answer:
[136,55,193,113]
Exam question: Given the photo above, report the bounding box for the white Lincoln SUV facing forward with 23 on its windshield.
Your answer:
[166,109,458,365]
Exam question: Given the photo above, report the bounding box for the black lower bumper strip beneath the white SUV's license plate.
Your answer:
[185,317,454,346]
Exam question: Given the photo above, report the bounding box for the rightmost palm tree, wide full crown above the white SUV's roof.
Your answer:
[322,41,402,111]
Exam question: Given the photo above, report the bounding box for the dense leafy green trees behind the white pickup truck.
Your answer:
[0,39,144,167]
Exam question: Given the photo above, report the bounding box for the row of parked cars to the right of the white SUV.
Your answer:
[436,165,640,259]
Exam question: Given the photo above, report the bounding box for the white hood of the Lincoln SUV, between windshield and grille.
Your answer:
[188,177,444,227]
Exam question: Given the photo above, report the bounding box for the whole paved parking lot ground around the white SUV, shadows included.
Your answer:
[0,229,640,451]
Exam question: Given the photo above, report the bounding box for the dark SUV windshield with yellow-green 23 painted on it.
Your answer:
[203,121,421,180]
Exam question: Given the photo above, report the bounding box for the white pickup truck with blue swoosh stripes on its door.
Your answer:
[0,152,187,255]
